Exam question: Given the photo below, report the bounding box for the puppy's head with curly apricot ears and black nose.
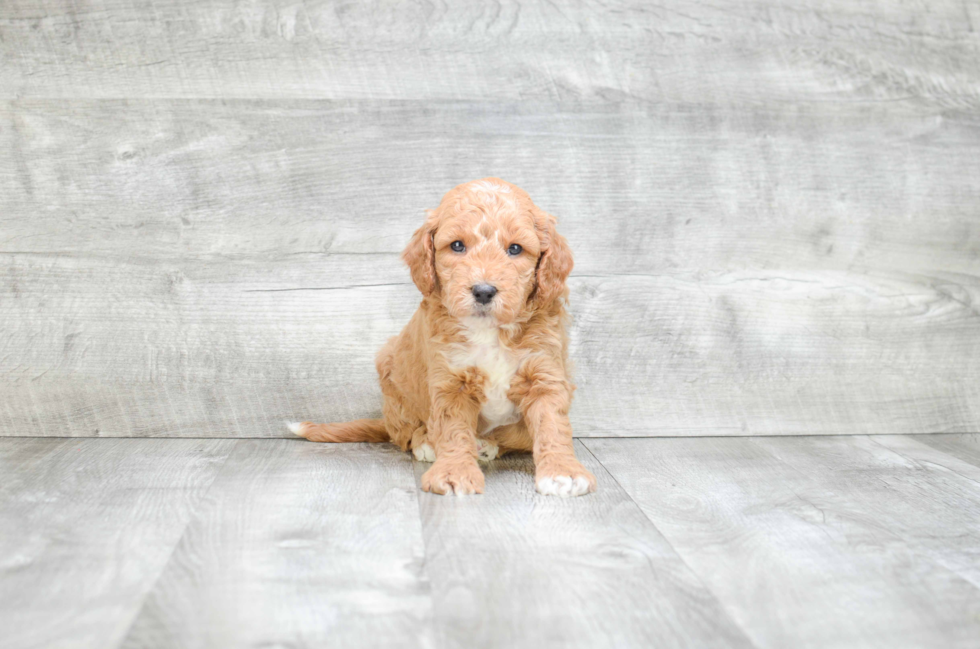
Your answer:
[402,178,572,325]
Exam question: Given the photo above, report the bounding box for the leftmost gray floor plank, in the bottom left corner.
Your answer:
[0,439,234,649]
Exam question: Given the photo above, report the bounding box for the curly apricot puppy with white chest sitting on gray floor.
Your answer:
[289,178,596,496]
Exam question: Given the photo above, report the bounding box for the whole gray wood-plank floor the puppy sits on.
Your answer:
[0,434,980,649]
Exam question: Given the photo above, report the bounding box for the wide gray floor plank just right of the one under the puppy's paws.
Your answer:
[584,437,980,648]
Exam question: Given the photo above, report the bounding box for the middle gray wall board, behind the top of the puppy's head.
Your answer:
[0,98,980,274]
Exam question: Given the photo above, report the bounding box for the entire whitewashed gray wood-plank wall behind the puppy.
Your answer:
[0,0,980,437]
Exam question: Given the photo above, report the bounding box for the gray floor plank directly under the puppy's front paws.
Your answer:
[415,445,751,648]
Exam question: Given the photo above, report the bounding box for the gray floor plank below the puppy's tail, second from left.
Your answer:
[122,440,432,648]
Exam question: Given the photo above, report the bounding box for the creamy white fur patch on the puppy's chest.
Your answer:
[448,318,520,435]
